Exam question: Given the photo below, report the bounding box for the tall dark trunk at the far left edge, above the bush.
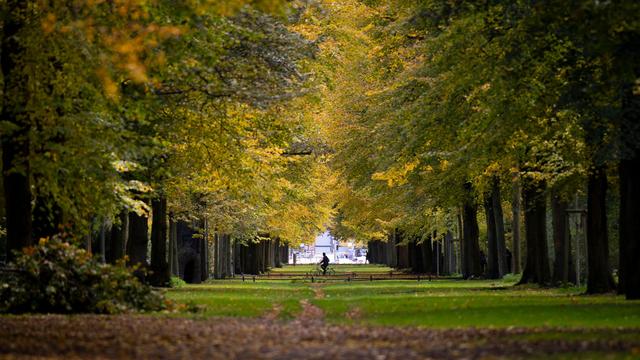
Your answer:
[0,0,33,261]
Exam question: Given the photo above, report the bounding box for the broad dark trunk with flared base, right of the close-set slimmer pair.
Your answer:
[519,176,551,285]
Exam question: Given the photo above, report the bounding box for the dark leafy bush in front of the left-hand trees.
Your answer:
[0,236,170,314]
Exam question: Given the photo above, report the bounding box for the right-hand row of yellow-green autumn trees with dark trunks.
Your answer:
[311,0,640,298]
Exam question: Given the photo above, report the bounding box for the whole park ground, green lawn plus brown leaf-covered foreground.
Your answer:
[0,266,640,360]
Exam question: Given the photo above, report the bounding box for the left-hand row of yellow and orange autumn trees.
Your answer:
[0,0,332,285]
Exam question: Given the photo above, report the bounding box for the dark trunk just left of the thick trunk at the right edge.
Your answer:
[587,166,615,294]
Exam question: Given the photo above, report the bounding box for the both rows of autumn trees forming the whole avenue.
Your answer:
[0,0,640,299]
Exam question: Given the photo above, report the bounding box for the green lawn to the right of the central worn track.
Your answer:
[313,280,640,327]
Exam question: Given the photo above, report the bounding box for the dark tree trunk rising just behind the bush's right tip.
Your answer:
[150,195,171,287]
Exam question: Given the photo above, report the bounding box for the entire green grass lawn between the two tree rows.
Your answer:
[167,265,640,328]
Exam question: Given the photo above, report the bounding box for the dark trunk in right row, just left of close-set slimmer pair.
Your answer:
[462,183,482,279]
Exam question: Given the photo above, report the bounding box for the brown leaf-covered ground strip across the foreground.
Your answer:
[0,315,640,360]
